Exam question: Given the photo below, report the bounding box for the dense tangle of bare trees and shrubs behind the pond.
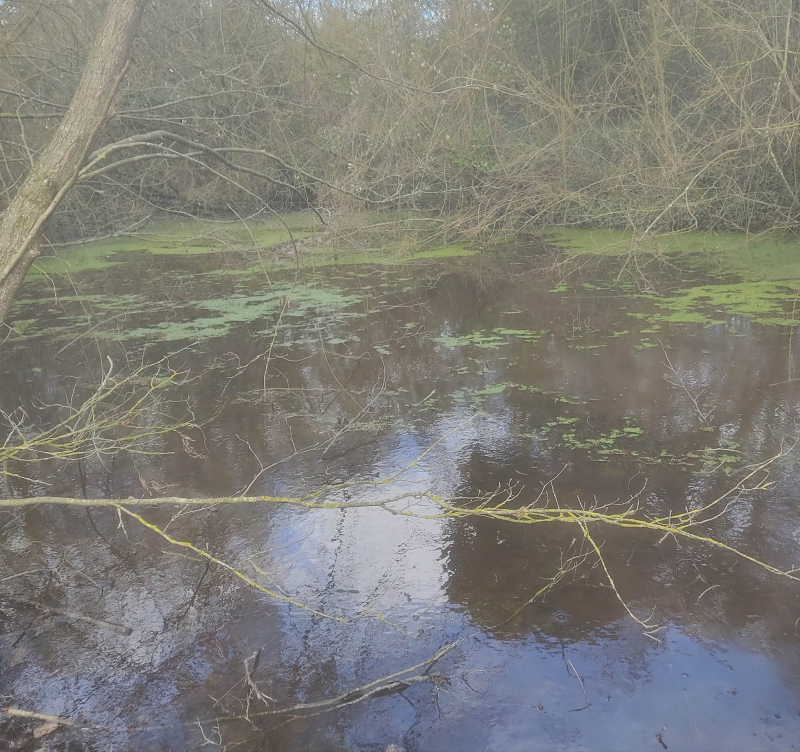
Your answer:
[0,0,800,242]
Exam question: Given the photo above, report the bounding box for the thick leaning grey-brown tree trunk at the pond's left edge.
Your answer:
[0,0,146,324]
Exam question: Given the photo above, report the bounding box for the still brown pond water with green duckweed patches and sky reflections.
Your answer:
[0,225,800,752]
